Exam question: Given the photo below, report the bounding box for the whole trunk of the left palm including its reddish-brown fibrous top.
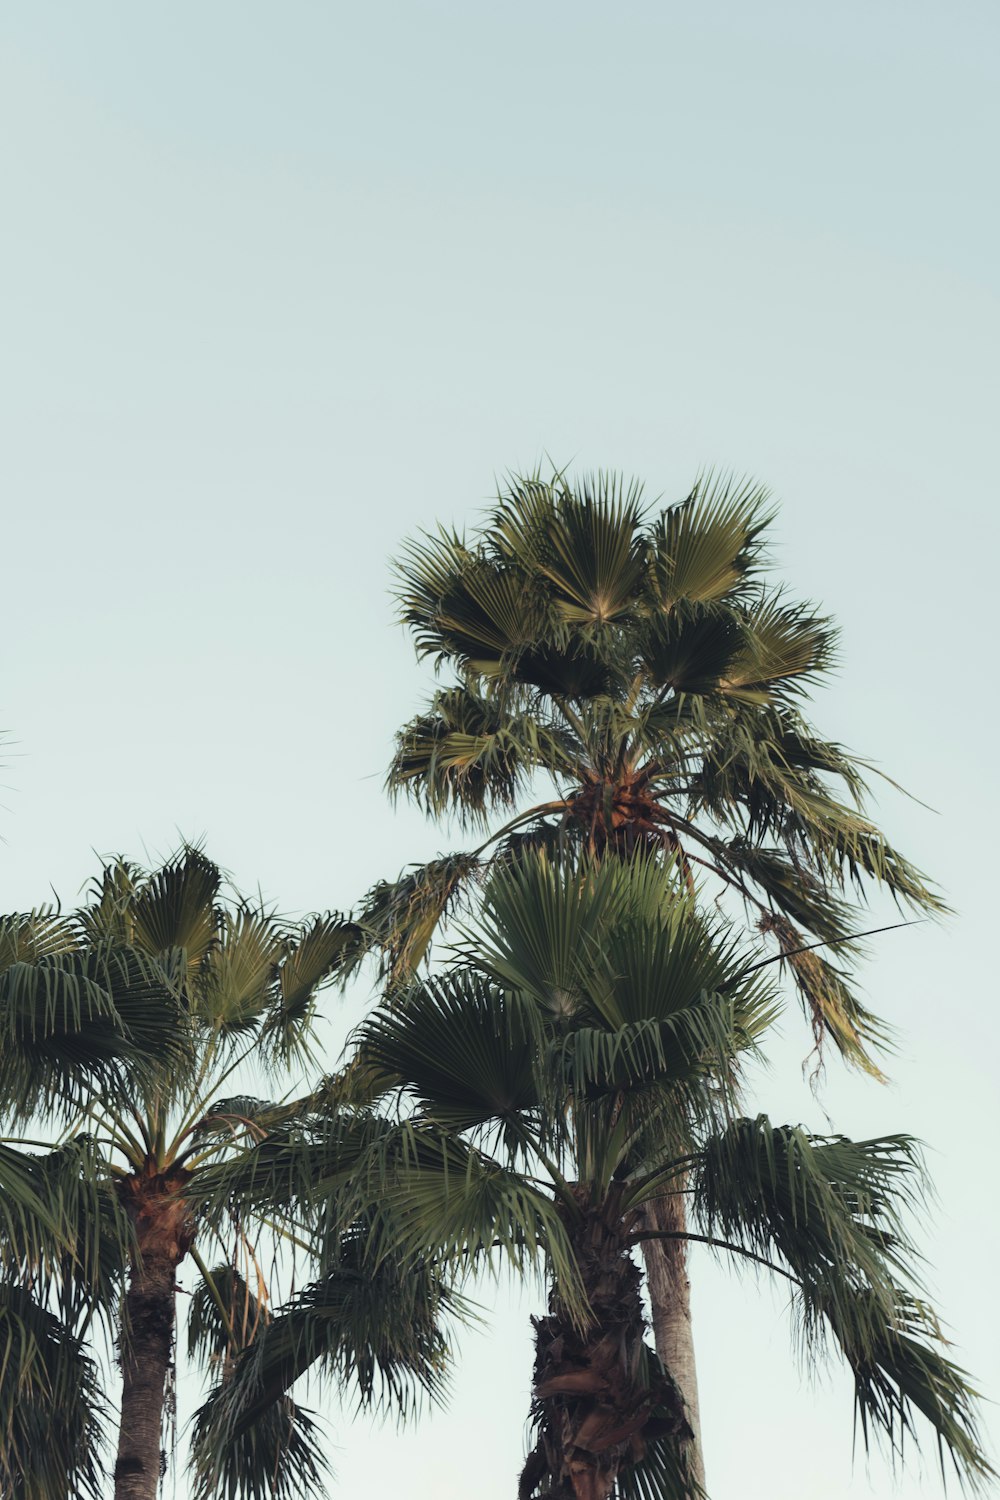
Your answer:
[114,1170,192,1500]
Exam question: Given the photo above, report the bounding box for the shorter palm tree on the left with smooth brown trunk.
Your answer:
[0,848,444,1500]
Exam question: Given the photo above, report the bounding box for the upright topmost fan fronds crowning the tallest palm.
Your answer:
[397,473,772,675]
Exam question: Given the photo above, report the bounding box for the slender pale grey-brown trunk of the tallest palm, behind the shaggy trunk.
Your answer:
[642,1193,705,1490]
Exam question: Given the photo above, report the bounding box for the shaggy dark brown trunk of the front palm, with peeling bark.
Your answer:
[519,1188,690,1500]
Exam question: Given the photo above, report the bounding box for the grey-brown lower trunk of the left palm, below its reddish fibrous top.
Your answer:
[114,1251,177,1500]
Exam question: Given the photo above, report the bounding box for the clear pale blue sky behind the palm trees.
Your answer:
[0,0,1000,1500]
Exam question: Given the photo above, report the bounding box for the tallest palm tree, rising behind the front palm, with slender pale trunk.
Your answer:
[360,474,942,1476]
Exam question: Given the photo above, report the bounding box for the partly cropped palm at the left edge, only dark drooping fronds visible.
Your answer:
[0,909,187,1500]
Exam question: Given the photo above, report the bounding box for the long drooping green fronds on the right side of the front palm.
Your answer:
[693,1116,991,1484]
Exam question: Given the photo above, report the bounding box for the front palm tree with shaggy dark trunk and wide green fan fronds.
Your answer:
[245,852,990,1500]
